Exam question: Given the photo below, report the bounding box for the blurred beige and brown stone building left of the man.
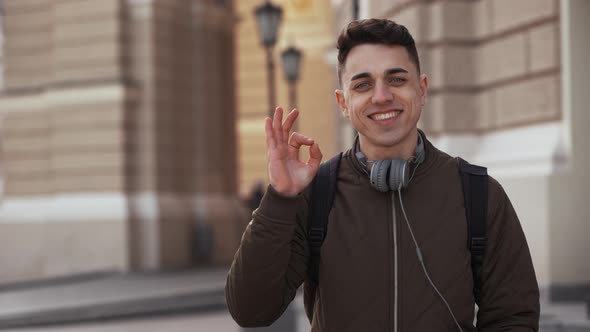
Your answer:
[0,0,247,281]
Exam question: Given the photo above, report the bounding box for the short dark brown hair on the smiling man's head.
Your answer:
[336,18,420,83]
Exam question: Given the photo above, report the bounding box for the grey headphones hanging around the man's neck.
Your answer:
[355,132,425,192]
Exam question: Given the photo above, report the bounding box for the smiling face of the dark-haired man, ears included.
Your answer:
[336,44,428,156]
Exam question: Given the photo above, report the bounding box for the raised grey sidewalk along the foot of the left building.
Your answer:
[0,268,227,329]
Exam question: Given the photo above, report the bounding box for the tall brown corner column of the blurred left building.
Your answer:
[128,0,249,269]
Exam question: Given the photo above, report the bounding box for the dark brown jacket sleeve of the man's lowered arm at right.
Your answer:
[477,178,540,331]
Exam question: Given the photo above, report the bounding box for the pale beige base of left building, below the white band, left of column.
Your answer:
[0,220,127,282]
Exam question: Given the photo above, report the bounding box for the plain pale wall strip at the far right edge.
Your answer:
[549,0,590,286]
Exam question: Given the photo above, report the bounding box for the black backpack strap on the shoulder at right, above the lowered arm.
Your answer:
[457,157,488,303]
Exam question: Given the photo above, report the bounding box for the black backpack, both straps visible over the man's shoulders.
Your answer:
[303,153,488,322]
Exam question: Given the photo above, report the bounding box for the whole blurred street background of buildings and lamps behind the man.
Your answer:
[0,0,590,332]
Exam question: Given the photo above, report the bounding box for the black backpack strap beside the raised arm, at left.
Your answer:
[303,153,342,321]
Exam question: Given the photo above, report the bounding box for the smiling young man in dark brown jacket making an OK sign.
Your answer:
[226,19,539,332]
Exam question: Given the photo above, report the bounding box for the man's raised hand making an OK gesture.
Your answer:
[264,107,322,196]
